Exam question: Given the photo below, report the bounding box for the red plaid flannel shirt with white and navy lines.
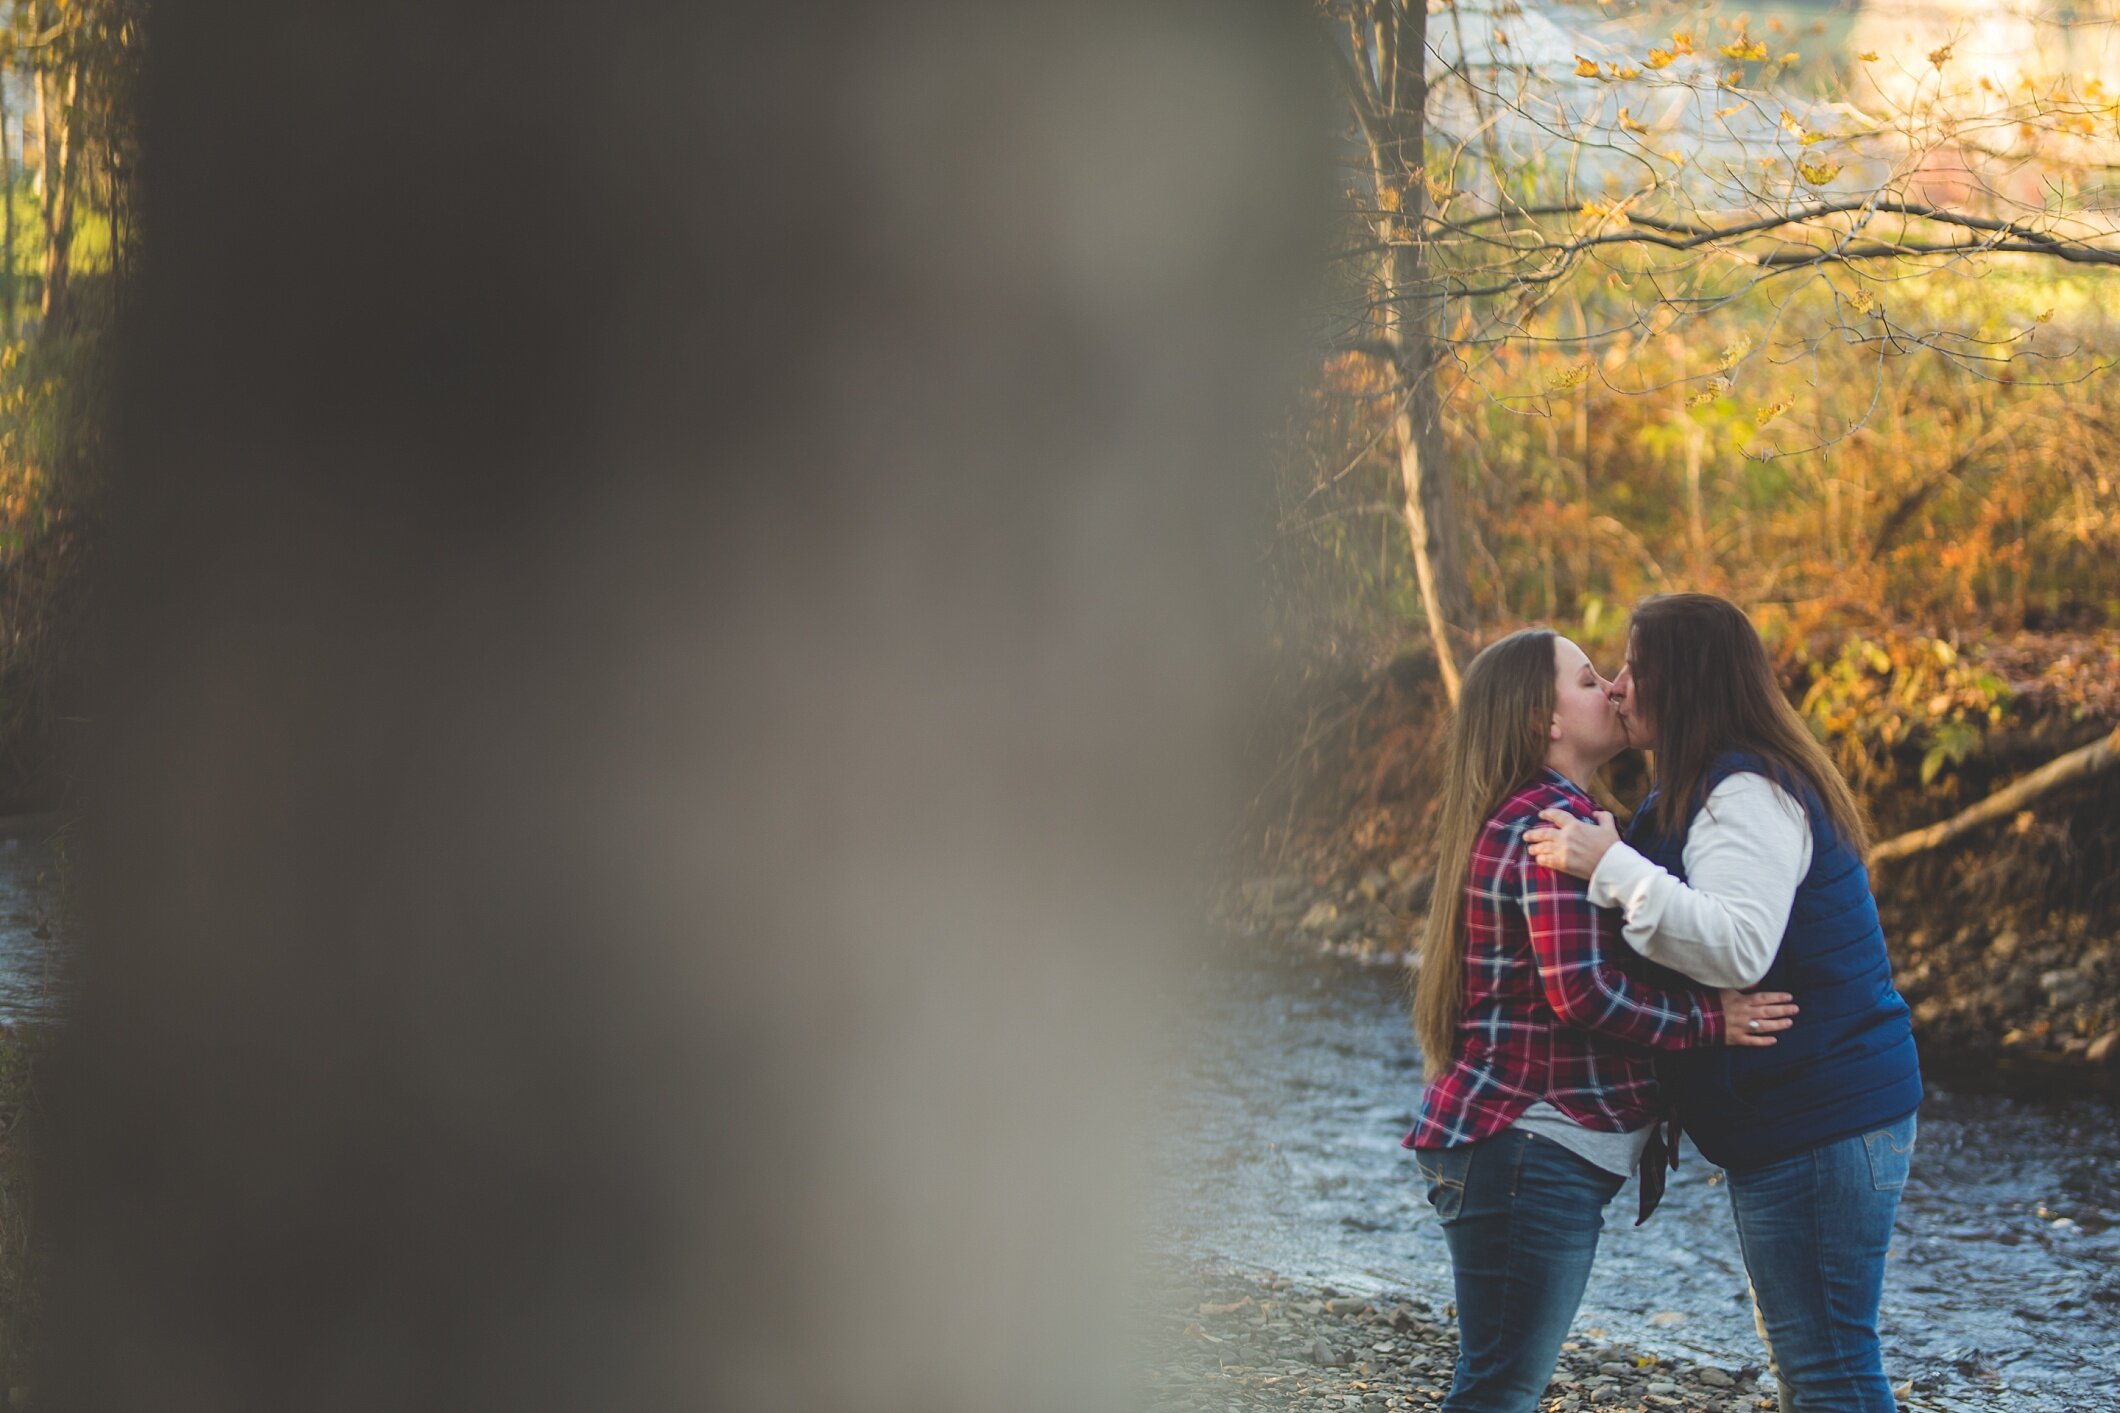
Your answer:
[1403,771,1724,1148]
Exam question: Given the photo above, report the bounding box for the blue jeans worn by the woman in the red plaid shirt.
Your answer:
[1414,1129,1626,1413]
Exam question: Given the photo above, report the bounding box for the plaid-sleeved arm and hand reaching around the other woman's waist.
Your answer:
[1516,830,1796,1051]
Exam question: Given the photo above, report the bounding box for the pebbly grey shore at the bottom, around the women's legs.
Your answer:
[1141,1271,1774,1413]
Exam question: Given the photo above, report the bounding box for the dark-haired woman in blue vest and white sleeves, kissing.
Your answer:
[1524,593,1921,1413]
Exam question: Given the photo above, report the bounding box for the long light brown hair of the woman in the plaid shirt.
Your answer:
[1414,627,1558,1078]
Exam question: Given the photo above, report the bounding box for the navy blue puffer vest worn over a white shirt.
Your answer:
[1628,752,1921,1169]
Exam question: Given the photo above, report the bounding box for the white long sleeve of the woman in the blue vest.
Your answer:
[1590,771,1810,987]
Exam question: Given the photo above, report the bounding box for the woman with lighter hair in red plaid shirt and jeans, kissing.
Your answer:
[1406,629,1796,1413]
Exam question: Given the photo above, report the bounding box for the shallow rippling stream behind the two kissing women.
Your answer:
[1158,943,2120,1413]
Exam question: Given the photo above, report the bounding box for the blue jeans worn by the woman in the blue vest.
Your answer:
[1730,1114,1914,1413]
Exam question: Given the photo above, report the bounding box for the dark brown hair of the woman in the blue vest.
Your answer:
[1626,593,1870,854]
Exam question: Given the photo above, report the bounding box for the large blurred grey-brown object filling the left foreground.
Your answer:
[36,0,1325,1413]
